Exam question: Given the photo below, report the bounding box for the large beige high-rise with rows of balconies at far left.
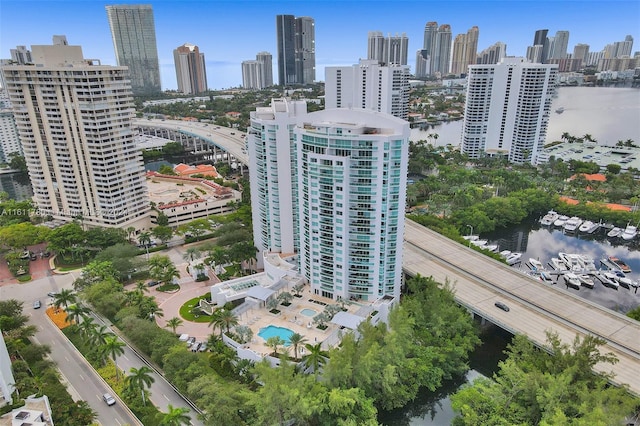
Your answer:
[2,38,149,228]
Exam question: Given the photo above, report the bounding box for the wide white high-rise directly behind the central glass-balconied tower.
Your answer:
[325,60,410,120]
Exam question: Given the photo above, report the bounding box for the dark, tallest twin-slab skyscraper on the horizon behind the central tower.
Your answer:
[276,15,316,86]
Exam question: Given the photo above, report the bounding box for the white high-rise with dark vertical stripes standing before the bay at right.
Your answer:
[462,57,558,164]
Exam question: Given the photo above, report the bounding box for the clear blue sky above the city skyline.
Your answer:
[0,0,640,90]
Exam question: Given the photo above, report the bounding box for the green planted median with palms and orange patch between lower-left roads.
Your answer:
[46,307,163,426]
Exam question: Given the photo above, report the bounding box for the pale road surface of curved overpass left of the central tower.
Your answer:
[133,118,249,165]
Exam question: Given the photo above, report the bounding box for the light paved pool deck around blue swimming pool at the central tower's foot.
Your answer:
[238,285,360,356]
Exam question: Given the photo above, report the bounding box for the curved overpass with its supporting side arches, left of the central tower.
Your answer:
[132,118,249,167]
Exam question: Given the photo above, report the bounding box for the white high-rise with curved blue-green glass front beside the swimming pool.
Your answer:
[247,99,410,301]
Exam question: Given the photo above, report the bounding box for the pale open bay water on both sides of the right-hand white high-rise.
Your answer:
[410,86,640,147]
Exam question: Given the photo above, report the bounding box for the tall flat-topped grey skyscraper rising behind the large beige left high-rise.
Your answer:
[106,5,162,95]
